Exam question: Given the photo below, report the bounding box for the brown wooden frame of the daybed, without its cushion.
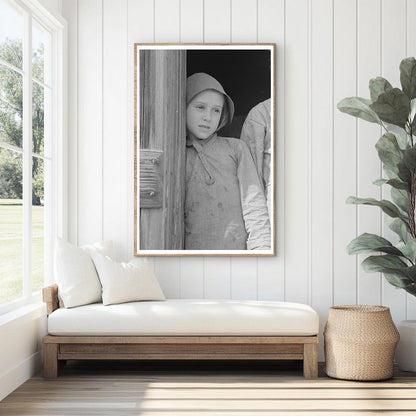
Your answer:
[43,285,318,378]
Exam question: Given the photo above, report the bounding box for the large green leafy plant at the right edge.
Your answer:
[338,58,416,296]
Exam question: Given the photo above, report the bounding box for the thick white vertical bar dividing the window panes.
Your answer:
[23,13,32,298]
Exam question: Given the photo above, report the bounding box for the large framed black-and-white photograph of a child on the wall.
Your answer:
[134,44,276,256]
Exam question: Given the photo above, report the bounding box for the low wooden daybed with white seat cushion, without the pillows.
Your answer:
[43,285,319,378]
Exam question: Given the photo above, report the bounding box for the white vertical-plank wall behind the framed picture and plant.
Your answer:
[62,0,416,358]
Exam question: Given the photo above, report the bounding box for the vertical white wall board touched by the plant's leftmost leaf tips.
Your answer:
[333,0,357,305]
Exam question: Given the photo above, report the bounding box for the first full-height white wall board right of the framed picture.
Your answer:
[285,0,310,302]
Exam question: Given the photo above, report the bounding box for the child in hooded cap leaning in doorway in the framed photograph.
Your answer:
[185,73,271,250]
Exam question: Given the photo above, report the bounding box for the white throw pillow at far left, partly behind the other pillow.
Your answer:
[55,239,113,308]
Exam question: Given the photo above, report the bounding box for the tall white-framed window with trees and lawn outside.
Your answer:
[0,0,65,312]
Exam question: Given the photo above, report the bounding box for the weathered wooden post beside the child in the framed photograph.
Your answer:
[136,50,186,252]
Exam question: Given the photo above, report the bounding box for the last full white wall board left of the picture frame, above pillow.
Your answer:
[103,0,128,260]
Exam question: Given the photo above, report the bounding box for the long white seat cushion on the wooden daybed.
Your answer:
[48,299,319,336]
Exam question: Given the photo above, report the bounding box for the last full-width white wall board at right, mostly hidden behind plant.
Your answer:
[382,0,407,321]
